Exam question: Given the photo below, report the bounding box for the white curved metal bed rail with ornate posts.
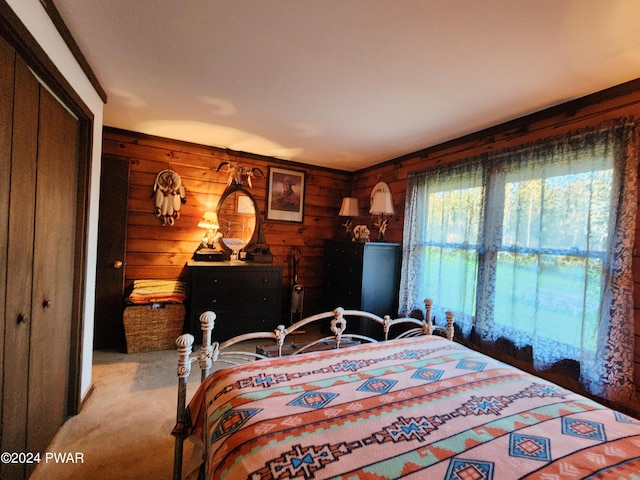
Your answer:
[172,299,454,480]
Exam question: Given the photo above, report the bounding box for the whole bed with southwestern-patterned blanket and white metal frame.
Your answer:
[174,305,640,480]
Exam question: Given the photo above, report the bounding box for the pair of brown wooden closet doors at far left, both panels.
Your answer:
[0,34,79,479]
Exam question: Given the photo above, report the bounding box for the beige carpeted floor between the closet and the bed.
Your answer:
[30,331,319,480]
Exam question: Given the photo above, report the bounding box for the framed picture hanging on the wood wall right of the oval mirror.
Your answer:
[266,167,305,223]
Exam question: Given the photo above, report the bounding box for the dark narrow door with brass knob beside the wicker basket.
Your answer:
[93,155,129,350]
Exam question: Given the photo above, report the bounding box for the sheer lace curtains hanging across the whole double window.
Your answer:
[400,122,638,403]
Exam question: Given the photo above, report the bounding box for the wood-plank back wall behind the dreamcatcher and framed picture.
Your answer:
[102,128,352,315]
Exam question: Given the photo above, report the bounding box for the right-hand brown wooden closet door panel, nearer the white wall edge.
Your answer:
[27,86,79,464]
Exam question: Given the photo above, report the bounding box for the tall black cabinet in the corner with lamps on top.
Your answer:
[323,240,401,336]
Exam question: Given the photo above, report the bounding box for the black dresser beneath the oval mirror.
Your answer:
[187,260,282,341]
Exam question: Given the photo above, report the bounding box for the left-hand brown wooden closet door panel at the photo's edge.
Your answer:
[0,40,39,478]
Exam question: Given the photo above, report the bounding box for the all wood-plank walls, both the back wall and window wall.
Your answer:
[103,80,640,392]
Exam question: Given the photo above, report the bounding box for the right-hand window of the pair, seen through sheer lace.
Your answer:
[484,154,614,365]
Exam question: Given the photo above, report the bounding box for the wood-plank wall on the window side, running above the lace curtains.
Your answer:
[353,80,640,387]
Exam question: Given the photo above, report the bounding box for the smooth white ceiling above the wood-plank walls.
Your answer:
[54,0,640,171]
